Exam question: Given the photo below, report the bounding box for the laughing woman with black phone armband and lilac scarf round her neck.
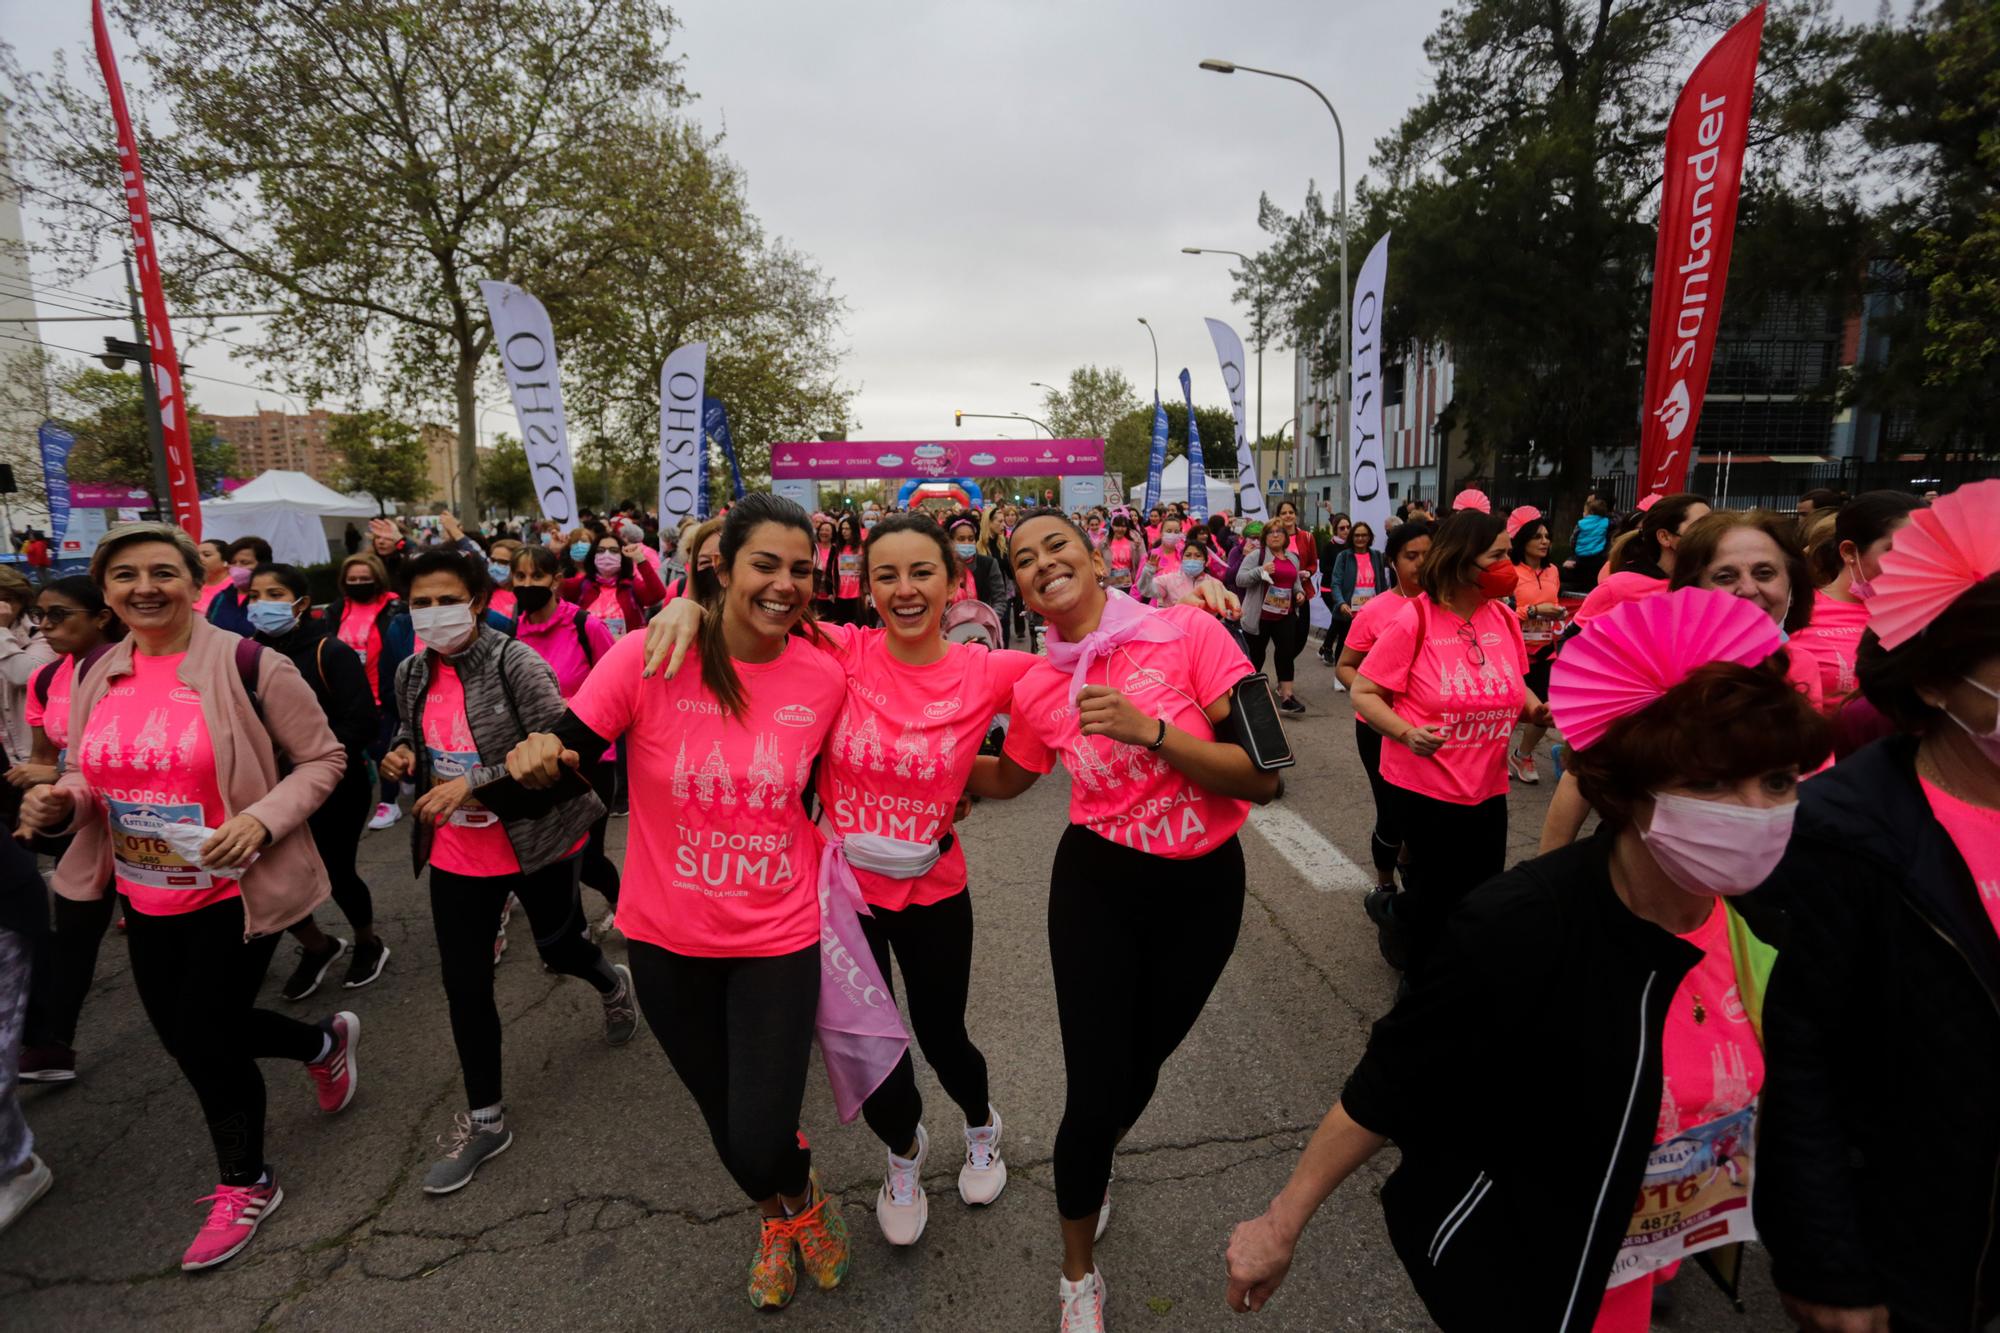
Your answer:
[970,510,1278,1327]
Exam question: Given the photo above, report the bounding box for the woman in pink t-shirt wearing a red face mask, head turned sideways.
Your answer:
[1354,510,1548,971]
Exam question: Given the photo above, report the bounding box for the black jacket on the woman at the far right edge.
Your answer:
[1754,737,2000,1333]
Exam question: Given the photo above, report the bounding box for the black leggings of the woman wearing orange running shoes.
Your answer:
[626,939,820,1203]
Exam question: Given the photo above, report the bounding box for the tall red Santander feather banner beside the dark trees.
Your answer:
[1638,4,1764,494]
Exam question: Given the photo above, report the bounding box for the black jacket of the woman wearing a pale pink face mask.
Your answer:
[1342,833,1702,1333]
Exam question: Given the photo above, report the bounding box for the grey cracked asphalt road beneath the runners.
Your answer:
[0,652,1788,1333]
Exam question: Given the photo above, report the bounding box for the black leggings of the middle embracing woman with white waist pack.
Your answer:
[860,891,990,1155]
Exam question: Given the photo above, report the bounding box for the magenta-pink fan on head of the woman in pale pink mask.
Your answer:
[1548,588,1784,749]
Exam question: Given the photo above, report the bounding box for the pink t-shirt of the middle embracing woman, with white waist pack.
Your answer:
[818,624,1038,913]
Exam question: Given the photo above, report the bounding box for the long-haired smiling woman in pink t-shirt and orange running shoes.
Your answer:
[508,492,848,1307]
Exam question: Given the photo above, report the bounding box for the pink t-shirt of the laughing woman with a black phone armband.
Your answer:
[1006,606,1252,861]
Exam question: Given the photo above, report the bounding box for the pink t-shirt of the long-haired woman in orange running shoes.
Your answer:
[570,634,848,959]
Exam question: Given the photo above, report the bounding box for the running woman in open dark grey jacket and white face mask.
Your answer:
[382,550,638,1195]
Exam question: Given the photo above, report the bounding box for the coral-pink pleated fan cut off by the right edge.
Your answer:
[1868,480,2000,648]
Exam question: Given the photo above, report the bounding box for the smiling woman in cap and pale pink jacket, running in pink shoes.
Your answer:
[22,522,360,1271]
